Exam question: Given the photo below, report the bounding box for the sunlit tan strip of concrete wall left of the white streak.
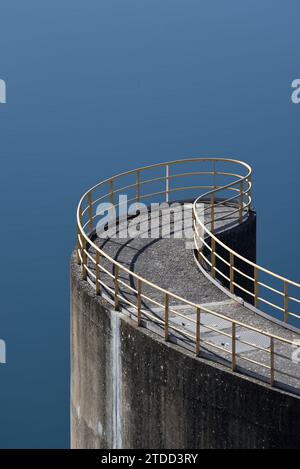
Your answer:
[71,266,113,448]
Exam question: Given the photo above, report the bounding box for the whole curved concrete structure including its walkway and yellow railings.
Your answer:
[71,158,300,449]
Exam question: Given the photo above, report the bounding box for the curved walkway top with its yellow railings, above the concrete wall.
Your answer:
[76,158,300,393]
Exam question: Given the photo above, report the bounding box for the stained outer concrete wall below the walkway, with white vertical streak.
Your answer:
[71,257,300,449]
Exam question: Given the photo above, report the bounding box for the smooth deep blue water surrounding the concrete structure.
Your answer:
[0,0,300,448]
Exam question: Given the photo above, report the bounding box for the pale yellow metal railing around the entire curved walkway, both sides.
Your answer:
[76,158,300,389]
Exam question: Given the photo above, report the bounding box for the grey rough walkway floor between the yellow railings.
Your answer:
[84,204,300,394]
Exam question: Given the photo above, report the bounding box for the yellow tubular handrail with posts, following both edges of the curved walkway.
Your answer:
[76,158,300,394]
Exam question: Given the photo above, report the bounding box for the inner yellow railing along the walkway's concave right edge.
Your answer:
[193,161,300,327]
